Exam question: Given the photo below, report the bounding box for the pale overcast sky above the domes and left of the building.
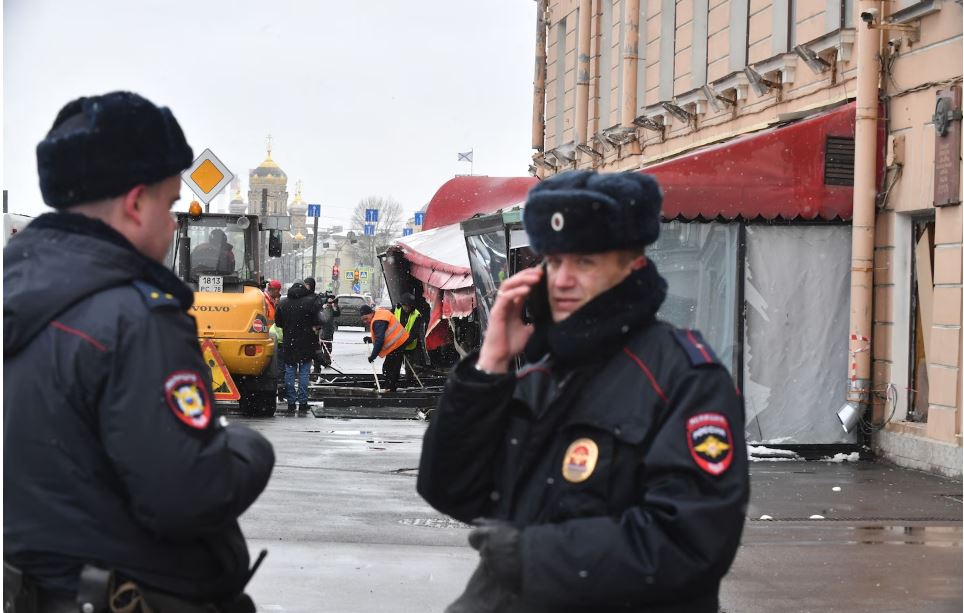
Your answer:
[3,0,536,226]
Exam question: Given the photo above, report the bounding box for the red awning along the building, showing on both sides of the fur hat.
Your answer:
[422,102,886,229]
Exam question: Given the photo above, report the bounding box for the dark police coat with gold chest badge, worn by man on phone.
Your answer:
[418,264,749,613]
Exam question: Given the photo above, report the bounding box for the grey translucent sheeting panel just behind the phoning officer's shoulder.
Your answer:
[646,221,739,373]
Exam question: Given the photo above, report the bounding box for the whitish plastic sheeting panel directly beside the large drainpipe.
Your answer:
[743,225,856,444]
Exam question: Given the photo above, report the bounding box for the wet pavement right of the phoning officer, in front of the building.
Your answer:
[721,461,964,613]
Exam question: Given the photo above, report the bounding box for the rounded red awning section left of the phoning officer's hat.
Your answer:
[422,177,539,230]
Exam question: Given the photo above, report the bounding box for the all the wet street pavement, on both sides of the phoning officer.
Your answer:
[234,331,962,613]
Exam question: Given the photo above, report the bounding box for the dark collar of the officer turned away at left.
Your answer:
[30,212,194,311]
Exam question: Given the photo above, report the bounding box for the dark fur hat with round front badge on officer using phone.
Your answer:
[523,170,663,255]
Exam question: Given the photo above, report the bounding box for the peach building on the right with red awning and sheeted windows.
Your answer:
[530,0,962,477]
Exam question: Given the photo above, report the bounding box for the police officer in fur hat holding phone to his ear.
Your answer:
[418,171,749,613]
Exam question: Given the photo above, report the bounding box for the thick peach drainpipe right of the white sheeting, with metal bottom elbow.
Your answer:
[837,0,882,432]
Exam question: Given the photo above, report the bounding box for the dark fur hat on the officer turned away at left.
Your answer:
[37,92,194,209]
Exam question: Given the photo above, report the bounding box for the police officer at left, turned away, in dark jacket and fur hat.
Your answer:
[3,92,274,613]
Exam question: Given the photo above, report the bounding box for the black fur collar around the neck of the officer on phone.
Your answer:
[525,260,667,367]
